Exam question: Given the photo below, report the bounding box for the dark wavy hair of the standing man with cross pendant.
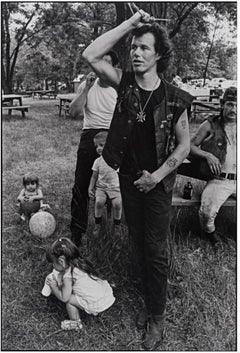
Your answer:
[130,23,172,73]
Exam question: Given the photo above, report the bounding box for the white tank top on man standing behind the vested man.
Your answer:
[79,78,117,130]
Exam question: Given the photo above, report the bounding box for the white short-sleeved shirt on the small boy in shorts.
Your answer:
[92,156,119,190]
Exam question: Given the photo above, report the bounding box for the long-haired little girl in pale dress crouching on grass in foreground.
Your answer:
[45,238,115,330]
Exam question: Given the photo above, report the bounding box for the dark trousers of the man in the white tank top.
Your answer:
[70,129,106,244]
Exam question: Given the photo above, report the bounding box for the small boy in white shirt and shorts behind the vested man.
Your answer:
[88,131,122,236]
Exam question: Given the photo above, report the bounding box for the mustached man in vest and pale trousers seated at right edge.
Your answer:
[190,87,237,245]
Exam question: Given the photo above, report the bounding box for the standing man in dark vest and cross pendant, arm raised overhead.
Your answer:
[83,10,193,350]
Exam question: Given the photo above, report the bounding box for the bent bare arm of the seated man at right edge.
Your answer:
[191,120,221,175]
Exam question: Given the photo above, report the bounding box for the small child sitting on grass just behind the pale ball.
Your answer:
[15,173,50,221]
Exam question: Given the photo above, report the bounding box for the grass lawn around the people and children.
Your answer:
[1,98,236,351]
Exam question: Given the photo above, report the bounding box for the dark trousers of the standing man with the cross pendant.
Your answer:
[119,174,172,315]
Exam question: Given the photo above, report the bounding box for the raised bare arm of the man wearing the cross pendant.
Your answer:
[83,10,149,89]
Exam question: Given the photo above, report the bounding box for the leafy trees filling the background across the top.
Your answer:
[1,2,237,92]
